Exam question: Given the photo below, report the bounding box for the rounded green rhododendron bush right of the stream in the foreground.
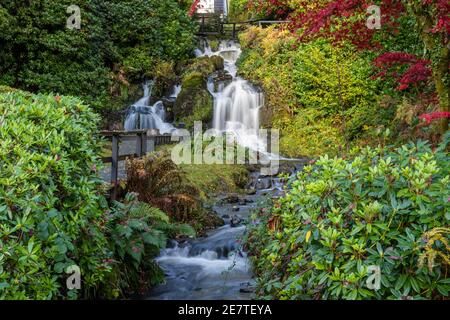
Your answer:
[246,134,450,299]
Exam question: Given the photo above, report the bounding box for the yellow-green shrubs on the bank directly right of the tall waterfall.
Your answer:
[239,27,384,156]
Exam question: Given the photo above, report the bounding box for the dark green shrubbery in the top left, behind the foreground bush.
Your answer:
[0,0,194,109]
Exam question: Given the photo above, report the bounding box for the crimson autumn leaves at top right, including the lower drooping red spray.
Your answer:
[250,0,450,99]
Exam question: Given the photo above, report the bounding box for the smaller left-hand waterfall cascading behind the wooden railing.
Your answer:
[124,82,179,134]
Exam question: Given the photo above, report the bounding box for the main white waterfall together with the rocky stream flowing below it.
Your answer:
[145,41,302,300]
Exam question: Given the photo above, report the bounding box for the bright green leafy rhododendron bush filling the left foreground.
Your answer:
[0,89,109,299]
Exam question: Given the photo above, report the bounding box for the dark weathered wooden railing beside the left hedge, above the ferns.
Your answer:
[100,130,172,200]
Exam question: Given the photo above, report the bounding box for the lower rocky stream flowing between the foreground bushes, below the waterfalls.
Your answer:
[146,172,290,300]
